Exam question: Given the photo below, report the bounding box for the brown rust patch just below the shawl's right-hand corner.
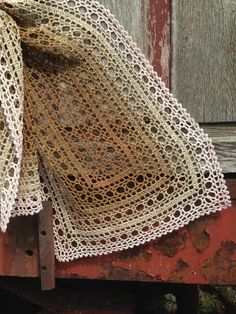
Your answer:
[187,214,219,253]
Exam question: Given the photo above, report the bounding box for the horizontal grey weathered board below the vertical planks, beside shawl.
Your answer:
[203,124,236,173]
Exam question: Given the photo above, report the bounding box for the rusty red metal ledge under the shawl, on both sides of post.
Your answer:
[0,180,236,284]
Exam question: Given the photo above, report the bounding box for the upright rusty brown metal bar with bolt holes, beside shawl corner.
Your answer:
[38,201,55,290]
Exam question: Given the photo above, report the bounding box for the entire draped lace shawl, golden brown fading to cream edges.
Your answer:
[0,0,230,261]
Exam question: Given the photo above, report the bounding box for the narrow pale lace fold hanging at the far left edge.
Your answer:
[0,11,24,231]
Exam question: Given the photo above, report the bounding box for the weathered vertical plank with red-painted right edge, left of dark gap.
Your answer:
[99,0,171,87]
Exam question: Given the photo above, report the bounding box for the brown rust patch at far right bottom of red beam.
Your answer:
[202,241,236,285]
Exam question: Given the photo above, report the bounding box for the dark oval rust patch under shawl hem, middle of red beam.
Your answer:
[154,231,187,257]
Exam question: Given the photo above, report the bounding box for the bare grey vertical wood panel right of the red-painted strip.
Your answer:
[172,0,236,122]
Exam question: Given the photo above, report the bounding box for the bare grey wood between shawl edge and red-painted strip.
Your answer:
[99,0,149,56]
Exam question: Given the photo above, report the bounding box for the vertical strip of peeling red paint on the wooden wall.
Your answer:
[148,0,170,87]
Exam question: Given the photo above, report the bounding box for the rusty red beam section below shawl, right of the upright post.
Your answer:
[56,205,236,284]
